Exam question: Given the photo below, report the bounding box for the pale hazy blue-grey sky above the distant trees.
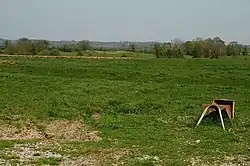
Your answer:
[0,0,250,44]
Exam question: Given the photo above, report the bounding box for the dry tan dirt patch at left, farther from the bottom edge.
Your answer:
[0,120,102,141]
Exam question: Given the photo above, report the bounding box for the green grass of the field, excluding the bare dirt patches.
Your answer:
[0,58,250,165]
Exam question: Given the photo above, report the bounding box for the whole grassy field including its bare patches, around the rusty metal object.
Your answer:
[0,57,250,166]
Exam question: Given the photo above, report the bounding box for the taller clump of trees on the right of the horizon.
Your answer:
[154,37,248,58]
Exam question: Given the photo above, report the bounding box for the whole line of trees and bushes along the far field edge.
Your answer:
[2,37,249,58]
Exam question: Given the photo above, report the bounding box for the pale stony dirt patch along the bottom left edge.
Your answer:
[0,141,130,166]
